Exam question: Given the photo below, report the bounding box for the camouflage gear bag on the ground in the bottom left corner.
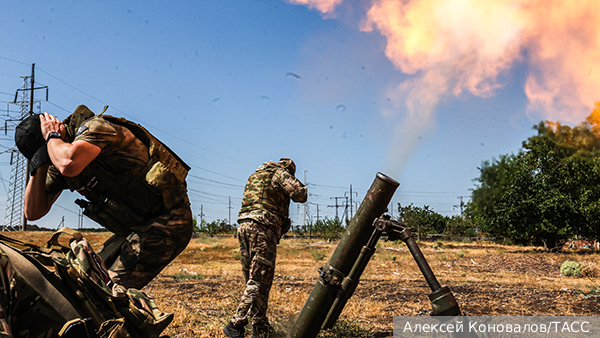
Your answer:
[0,228,173,338]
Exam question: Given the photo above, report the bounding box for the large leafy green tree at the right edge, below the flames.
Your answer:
[466,106,600,247]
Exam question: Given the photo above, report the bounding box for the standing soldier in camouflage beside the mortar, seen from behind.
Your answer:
[224,158,307,338]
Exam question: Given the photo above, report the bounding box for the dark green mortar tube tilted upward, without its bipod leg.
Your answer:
[290,173,400,338]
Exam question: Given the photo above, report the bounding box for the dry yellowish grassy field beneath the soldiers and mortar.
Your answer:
[3,233,600,338]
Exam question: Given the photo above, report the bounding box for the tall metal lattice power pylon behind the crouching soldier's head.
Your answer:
[2,63,48,231]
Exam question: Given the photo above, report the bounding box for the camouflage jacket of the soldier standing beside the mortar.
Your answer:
[238,161,308,238]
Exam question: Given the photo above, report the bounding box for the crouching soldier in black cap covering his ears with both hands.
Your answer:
[15,105,193,289]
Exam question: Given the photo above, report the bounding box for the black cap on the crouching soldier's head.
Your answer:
[15,114,50,176]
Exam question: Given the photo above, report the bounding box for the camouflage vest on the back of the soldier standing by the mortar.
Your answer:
[240,167,290,220]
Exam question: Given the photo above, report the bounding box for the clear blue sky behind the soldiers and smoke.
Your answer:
[0,0,596,228]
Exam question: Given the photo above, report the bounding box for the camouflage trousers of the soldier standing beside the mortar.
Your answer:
[231,220,277,327]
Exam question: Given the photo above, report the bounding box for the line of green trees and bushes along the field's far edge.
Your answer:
[196,102,600,248]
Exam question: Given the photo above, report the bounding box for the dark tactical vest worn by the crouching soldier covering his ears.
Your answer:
[59,110,190,236]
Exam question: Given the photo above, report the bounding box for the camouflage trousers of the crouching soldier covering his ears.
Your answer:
[98,198,193,289]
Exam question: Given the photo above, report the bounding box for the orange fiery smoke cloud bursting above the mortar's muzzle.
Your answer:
[291,0,600,171]
